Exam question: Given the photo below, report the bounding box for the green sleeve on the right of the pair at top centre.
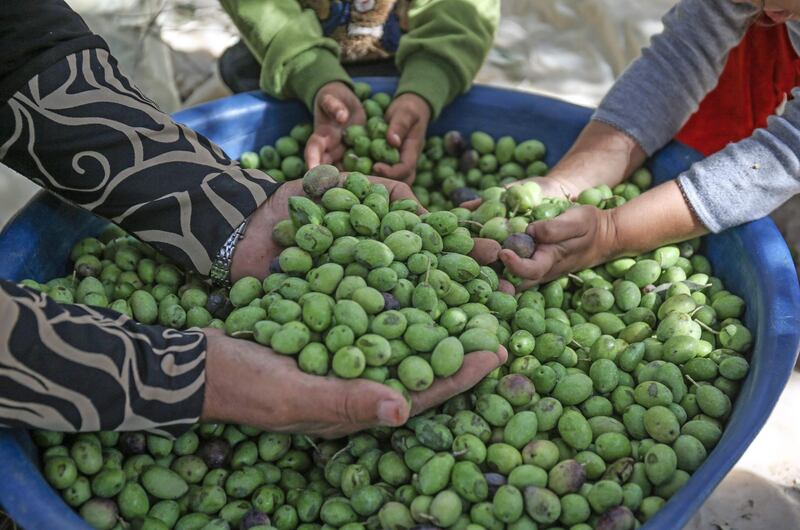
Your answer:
[396,0,500,118]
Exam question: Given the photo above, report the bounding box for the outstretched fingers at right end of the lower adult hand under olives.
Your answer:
[411,346,508,416]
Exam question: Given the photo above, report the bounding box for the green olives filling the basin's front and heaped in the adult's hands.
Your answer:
[24,139,753,530]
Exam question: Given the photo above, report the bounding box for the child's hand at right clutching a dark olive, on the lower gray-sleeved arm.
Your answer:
[500,206,619,290]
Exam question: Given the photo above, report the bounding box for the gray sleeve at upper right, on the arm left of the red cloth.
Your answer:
[593,0,756,155]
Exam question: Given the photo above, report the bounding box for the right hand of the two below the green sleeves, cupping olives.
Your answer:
[373,93,431,184]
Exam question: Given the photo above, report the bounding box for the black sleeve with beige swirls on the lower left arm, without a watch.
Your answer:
[0,280,206,434]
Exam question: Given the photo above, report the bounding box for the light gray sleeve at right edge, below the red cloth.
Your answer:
[678,89,800,232]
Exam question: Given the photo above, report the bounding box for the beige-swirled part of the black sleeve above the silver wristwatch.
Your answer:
[0,48,278,275]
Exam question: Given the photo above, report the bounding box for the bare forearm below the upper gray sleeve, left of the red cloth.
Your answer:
[548,121,646,196]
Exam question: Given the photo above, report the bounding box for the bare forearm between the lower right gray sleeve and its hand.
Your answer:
[609,181,708,256]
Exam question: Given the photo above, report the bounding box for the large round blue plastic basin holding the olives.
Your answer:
[0,79,800,530]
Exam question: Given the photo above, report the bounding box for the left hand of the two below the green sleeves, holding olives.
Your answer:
[305,81,367,169]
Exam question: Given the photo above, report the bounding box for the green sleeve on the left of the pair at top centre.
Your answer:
[221,0,352,109]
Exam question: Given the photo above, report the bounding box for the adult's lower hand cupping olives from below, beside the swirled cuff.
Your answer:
[202,329,508,438]
